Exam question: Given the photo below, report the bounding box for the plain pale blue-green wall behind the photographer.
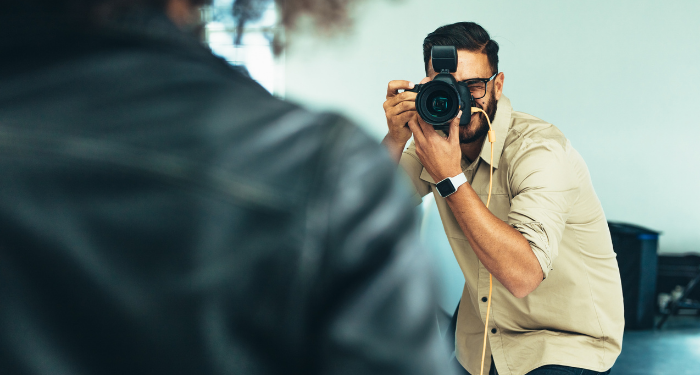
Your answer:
[286,0,700,308]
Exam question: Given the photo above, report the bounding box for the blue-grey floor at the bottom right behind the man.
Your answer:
[610,316,700,375]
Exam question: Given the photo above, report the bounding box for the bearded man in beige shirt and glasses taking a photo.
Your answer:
[383,22,624,375]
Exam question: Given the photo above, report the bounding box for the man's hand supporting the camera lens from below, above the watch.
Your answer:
[408,111,462,183]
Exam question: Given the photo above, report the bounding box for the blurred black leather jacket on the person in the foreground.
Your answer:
[0,10,446,375]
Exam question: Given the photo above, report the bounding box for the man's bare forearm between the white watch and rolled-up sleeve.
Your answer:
[446,184,543,298]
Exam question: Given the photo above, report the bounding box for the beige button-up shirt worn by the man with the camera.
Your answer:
[400,96,624,375]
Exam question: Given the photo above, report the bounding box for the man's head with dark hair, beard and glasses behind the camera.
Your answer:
[423,22,504,143]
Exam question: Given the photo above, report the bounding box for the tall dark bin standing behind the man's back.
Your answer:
[608,222,661,329]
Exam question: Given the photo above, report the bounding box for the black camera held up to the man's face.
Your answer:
[406,46,475,130]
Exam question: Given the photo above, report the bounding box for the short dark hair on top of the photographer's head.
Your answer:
[423,22,498,75]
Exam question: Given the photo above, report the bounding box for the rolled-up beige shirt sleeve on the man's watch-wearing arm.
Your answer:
[508,138,579,278]
